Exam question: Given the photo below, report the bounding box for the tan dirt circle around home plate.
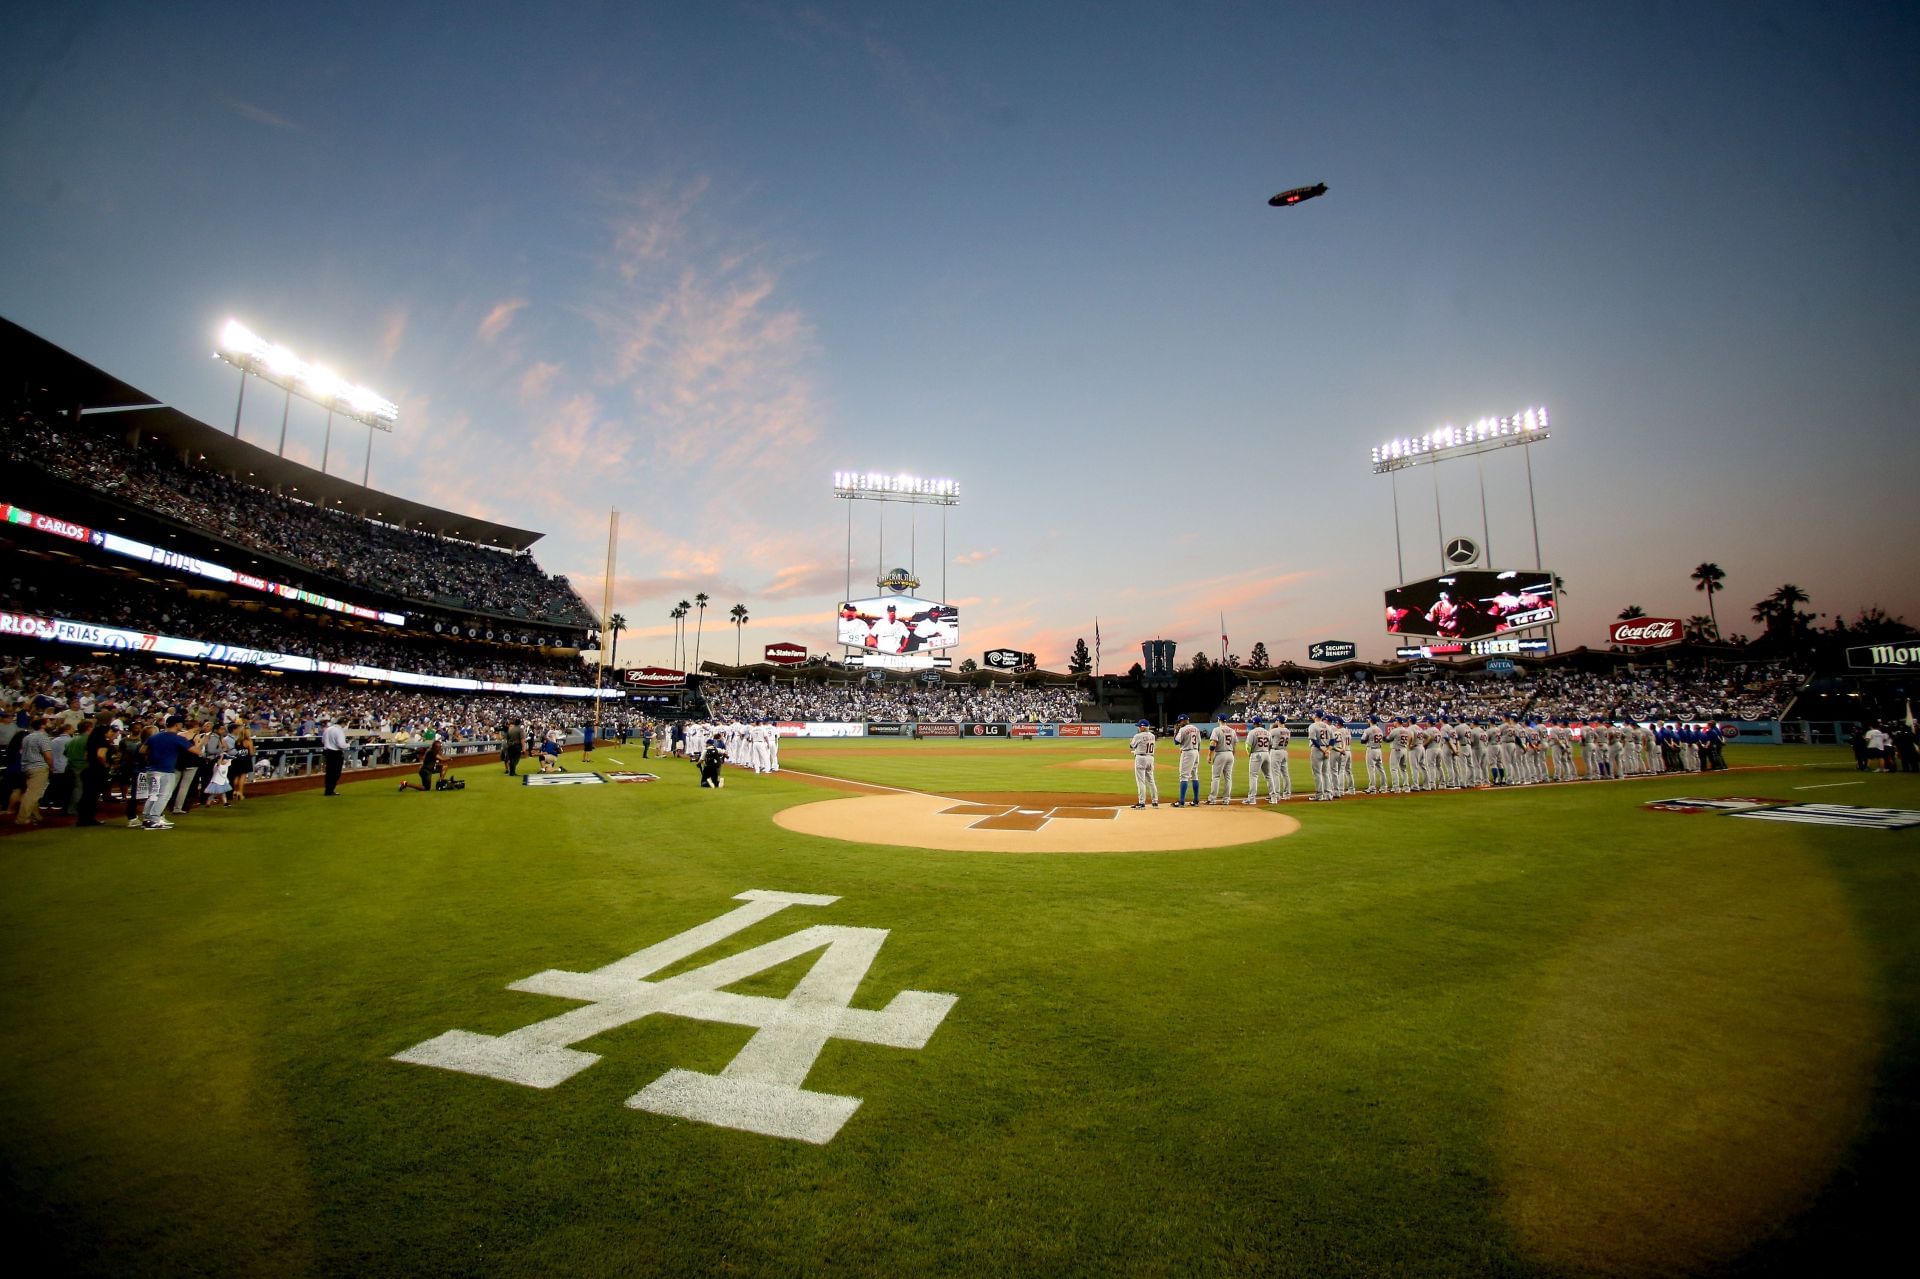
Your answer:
[774,791,1300,853]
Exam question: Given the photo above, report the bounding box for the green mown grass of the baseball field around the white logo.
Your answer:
[0,741,1920,1275]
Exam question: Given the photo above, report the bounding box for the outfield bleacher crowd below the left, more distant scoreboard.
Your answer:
[703,678,1081,724]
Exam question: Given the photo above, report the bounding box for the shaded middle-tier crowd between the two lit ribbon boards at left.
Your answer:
[0,572,593,688]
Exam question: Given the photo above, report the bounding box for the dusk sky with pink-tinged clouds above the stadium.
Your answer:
[0,2,1920,670]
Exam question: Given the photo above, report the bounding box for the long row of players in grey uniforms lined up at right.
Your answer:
[1127,711,1726,808]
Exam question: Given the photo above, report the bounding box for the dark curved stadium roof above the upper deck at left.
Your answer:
[0,319,543,551]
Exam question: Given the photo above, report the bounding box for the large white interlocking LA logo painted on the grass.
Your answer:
[394,889,958,1145]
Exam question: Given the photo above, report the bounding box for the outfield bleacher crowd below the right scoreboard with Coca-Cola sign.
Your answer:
[1229,663,1803,724]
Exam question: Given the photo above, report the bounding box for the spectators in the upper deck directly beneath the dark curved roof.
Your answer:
[0,409,593,628]
